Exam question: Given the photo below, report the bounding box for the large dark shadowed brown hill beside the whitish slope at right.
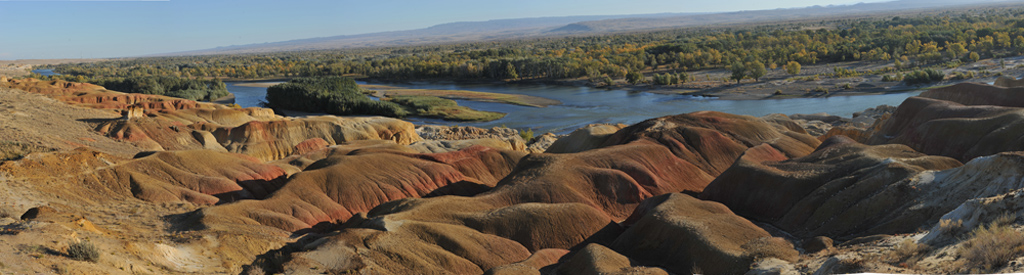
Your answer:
[700,136,959,238]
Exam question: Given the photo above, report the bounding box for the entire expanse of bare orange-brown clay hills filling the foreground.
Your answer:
[8,79,1024,274]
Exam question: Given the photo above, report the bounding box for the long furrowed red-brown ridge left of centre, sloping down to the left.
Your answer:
[194,146,522,231]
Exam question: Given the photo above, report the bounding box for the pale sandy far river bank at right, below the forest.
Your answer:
[536,56,1024,100]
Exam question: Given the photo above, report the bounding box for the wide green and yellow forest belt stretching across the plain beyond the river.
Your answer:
[34,6,1024,85]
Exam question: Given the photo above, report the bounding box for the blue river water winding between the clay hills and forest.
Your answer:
[227,83,921,134]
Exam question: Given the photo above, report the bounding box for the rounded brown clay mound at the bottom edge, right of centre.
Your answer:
[611,194,798,274]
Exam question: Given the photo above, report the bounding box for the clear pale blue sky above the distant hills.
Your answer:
[0,0,897,60]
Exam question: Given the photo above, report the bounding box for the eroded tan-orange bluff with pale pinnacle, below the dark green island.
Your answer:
[96,110,420,161]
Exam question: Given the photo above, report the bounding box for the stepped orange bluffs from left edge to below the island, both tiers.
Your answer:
[0,80,420,161]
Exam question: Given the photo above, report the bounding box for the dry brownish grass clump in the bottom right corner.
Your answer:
[957,217,1024,271]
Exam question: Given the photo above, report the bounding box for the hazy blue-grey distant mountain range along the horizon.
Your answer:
[159,0,1024,56]
